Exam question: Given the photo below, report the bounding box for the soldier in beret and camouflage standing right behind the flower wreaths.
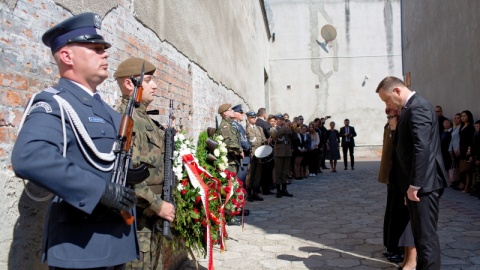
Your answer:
[215,103,244,173]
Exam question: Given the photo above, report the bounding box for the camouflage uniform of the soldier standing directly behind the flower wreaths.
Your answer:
[215,117,243,173]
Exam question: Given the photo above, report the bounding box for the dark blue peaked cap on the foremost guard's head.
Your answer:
[42,12,112,53]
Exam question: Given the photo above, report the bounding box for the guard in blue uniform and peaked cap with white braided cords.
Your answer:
[12,13,138,270]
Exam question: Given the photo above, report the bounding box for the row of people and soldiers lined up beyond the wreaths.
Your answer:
[217,103,357,201]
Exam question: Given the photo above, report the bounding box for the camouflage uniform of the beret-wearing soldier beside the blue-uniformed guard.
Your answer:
[118,96,165,270]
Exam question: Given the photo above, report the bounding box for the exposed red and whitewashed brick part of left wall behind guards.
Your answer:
[0,0,248,269]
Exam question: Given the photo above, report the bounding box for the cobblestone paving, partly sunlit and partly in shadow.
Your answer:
[181,161,480,270]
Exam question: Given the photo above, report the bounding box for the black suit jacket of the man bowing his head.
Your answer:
[394,94,447,193]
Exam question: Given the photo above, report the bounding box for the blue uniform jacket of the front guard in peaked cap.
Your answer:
[12,78,139,268]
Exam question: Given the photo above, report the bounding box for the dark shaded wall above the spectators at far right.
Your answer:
[402,0,480,120]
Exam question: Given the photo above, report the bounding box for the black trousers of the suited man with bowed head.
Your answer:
[407,189,443,270]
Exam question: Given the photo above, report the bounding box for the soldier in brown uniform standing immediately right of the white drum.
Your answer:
[270,113,293,198]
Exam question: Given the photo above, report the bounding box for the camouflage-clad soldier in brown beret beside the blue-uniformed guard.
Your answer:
[113,58,175,270]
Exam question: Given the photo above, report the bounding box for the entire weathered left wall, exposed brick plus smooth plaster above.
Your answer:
[0,0,269,269]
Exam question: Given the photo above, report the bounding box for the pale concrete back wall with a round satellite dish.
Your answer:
[270,0,402,157]
